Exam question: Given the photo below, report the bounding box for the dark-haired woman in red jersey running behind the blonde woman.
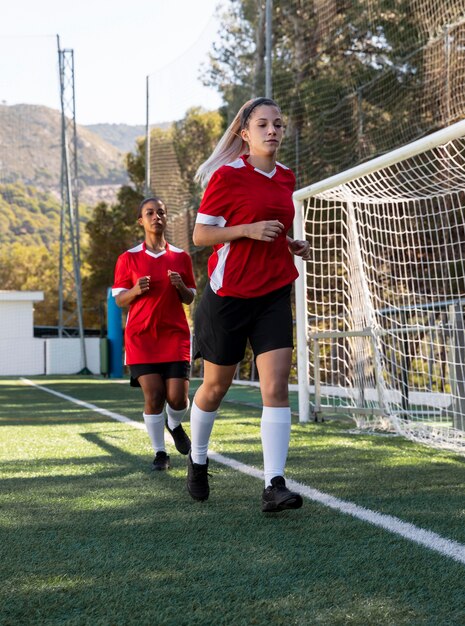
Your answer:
[112,197,195,470]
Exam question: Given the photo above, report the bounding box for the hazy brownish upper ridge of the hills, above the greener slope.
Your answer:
[0,104,127,204]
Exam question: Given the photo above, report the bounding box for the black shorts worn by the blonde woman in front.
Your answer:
[194,284,294,365]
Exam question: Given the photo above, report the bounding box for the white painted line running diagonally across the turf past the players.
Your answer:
[20,378,465,564]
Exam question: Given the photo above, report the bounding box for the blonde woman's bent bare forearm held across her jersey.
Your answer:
[192,220,284,246]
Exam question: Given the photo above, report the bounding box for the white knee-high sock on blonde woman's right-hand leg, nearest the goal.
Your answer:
[260,406,291,487]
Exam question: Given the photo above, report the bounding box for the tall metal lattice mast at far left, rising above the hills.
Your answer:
[57,35,90,374]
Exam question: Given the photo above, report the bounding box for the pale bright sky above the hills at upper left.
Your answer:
[0,0,225,125]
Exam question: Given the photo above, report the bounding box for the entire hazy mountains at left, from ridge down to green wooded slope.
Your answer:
[0,104,152,247]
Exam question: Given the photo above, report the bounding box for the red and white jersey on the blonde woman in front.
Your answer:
[196,155,298,298]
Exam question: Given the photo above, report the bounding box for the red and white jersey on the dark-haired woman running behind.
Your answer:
[112,242,195,365]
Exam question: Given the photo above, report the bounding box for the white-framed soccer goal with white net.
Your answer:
[294,121,465,452]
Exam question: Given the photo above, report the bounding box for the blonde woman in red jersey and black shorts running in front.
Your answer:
[187,98,310,512]
